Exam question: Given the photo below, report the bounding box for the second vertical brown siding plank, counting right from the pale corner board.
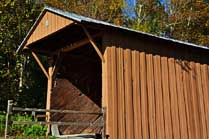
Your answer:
[117,48,126,139]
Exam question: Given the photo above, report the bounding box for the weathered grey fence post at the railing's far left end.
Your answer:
[4,100,13,139]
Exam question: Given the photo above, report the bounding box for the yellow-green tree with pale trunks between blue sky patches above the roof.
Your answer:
[126,0,166,35]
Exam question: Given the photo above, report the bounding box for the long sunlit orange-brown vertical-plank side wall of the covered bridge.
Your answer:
[103,47,209,139]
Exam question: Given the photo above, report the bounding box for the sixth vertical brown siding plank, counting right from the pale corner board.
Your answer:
[146,54,156,139]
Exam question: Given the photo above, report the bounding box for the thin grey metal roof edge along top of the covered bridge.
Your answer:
[17,6,209,52]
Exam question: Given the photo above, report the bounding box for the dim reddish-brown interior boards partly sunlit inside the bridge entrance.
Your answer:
[51,78,101,134]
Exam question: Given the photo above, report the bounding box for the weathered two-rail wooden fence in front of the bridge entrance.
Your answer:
[5,100,106,139]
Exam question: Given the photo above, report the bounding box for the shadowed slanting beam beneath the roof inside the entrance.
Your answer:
[61,32,102,52]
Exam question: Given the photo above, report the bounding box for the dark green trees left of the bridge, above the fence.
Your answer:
[0,0,46,110]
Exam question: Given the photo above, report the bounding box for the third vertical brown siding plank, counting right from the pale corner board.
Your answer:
[124,49,134,139]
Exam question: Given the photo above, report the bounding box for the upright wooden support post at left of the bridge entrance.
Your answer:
[46,66,53,135]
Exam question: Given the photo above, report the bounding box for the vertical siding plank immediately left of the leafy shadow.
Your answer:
[168,58,180,139]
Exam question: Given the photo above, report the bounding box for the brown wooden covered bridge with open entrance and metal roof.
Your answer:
[17,7,209,139]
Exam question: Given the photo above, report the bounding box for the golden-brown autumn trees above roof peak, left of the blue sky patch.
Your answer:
[44,0,125,25]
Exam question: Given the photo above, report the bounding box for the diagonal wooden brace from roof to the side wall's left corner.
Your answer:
[82,25,105,62]
